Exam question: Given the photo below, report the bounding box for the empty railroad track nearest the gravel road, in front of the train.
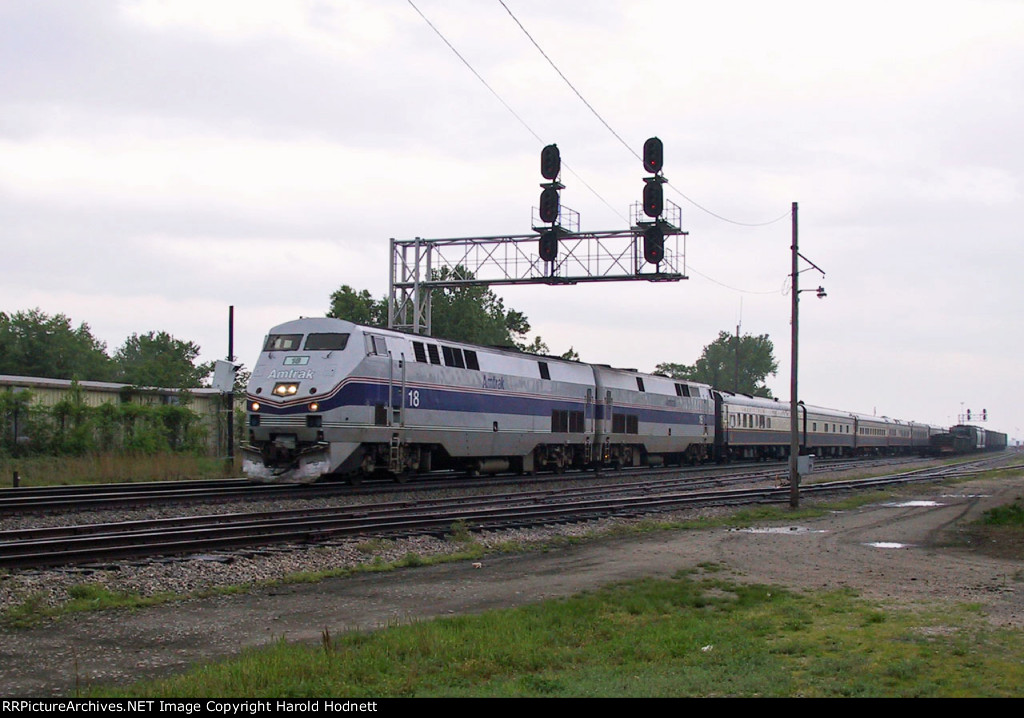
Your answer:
[0,457,1024,569]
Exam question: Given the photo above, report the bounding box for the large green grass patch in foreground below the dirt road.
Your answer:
[90,566,1024,699]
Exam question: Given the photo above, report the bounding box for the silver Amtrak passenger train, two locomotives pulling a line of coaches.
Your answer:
[243,319,1006,481]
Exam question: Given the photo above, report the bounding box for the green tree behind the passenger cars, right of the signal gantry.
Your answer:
[654,332,778,397]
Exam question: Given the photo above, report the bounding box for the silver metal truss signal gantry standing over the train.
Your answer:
[388,202,688,335]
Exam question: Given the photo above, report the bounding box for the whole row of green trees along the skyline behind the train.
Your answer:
[0,285,778,396]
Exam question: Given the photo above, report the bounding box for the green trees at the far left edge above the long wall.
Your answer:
[0,307,114,381]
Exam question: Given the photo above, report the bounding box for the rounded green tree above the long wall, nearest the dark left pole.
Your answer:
[114,332,214,389]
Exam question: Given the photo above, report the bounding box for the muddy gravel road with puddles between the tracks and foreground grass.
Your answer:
[0,465,1024,696]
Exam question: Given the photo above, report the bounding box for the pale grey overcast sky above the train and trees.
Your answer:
[0,0,1024,437]
